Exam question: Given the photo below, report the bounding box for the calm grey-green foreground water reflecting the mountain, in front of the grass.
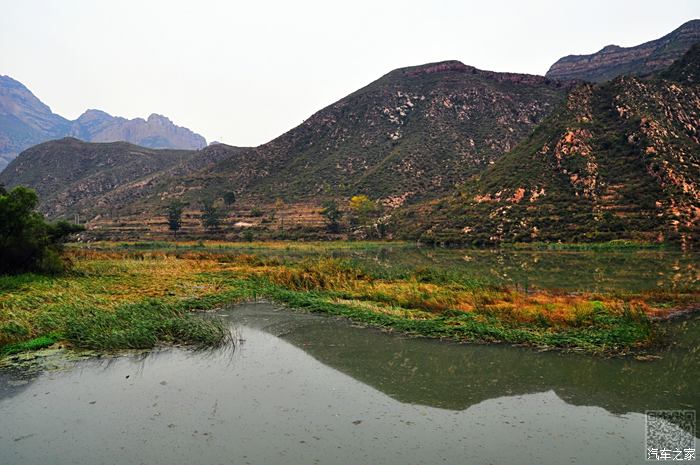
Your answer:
[0,304,700,465]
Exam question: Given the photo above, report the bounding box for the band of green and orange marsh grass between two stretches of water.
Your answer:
[0,244,698,355]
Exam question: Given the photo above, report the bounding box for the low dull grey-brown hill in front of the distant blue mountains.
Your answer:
[0,138,242,219]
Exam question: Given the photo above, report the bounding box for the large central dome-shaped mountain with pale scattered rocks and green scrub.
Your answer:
[137,61,568,210]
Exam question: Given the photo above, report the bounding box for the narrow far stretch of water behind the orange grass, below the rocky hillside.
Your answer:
[314,247,700,292]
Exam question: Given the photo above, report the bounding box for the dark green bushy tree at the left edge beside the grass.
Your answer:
[0,187,84,274]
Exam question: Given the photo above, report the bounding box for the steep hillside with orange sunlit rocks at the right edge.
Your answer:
[394,47,700,244]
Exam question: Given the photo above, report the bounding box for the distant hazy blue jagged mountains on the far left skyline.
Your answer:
[0,76,207,171]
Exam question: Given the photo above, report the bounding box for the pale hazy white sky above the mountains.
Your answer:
[0,0,700,145]
